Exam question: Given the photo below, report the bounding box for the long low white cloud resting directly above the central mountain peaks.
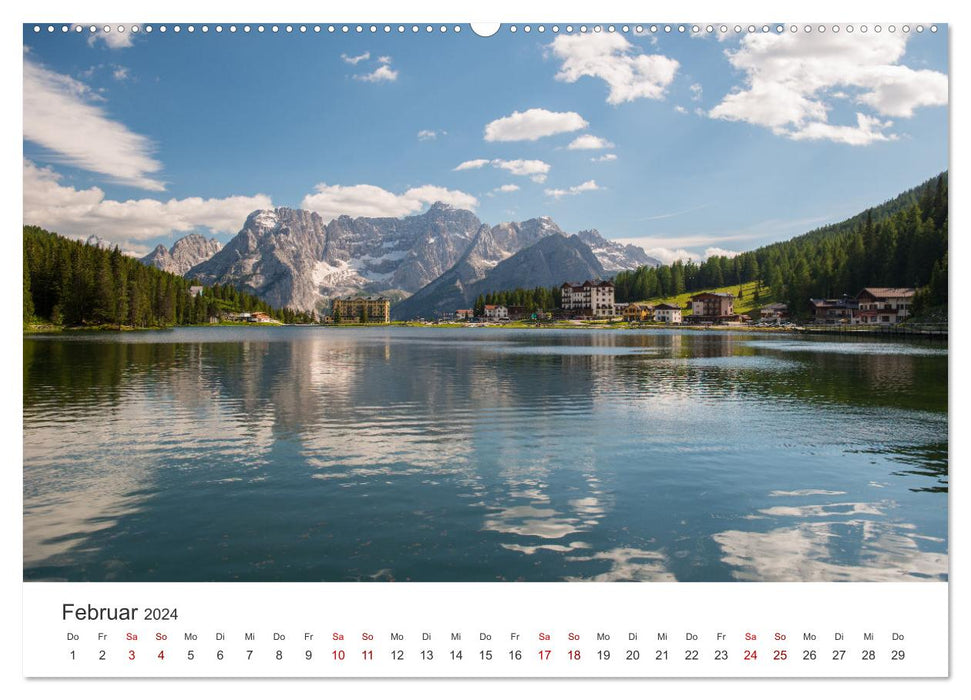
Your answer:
[300,183,479,221]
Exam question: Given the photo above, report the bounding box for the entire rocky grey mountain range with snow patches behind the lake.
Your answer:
[142,202,659,317]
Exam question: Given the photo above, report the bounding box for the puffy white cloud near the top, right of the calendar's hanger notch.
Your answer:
[550,32,679,104]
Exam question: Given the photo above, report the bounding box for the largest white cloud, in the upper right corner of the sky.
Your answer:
[708,32,948,145]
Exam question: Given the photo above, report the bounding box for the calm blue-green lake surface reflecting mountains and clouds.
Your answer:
[24,328,948,581]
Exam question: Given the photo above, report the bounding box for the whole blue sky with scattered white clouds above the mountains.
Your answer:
[24,25,948,260]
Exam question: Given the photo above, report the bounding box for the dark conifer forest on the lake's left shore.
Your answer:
[23,226,313,328]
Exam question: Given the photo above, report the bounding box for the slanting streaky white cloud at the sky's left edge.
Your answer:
[24,57,165,191]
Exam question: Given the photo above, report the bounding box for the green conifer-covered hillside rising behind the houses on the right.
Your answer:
[614,172,948,313]
